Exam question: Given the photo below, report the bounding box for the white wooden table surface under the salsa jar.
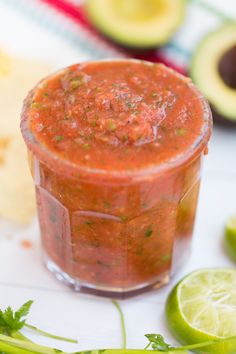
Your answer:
[0,0,236,351]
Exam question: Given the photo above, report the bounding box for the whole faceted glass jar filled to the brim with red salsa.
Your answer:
[21,60,212,296]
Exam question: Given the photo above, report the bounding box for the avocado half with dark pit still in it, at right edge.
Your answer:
[190,22,236,124]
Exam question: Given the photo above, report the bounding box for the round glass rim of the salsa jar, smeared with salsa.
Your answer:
[21,58,212,181]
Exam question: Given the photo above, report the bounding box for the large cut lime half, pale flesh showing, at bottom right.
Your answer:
[166,268,236,354]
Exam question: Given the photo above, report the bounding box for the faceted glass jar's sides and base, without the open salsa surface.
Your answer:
[21,59,212,297]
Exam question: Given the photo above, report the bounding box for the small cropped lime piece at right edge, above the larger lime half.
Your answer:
[224,216,236,262]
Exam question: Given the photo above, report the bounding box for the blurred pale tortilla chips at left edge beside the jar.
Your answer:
[0,51,51,224]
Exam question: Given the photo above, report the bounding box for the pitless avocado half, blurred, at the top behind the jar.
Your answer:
[86,0,186,48]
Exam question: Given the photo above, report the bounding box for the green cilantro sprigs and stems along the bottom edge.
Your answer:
[0,300,236,354]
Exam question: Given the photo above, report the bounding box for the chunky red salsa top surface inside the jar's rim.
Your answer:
[29,62,208,171]
